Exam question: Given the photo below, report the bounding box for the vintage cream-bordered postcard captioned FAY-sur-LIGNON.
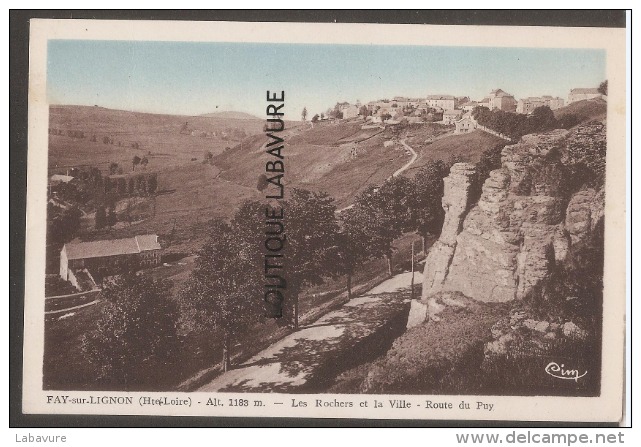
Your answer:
[23,19,627,422]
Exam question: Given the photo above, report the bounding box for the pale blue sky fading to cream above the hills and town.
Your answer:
[47,40,606,119]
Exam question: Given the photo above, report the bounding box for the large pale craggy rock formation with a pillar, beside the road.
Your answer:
[422,123,605,302]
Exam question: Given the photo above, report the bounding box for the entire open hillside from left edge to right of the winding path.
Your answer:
[49,106,501,214]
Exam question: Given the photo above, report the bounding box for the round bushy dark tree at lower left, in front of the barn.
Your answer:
[81,274,180,390]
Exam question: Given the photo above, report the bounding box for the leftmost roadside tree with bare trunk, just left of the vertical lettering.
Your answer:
[181,220,264,371]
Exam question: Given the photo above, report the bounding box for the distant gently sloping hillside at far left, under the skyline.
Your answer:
[49,106,263,173]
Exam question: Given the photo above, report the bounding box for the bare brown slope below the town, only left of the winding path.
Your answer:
[214,122,398,206]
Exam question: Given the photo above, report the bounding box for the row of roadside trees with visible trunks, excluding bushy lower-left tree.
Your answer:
[180,150,501,370]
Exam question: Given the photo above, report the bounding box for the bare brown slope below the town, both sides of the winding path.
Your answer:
[214,121,504,207]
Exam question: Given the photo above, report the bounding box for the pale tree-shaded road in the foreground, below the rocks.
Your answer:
[198,272,422,392]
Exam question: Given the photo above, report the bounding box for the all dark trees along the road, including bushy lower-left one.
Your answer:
[83,146,501,385]
